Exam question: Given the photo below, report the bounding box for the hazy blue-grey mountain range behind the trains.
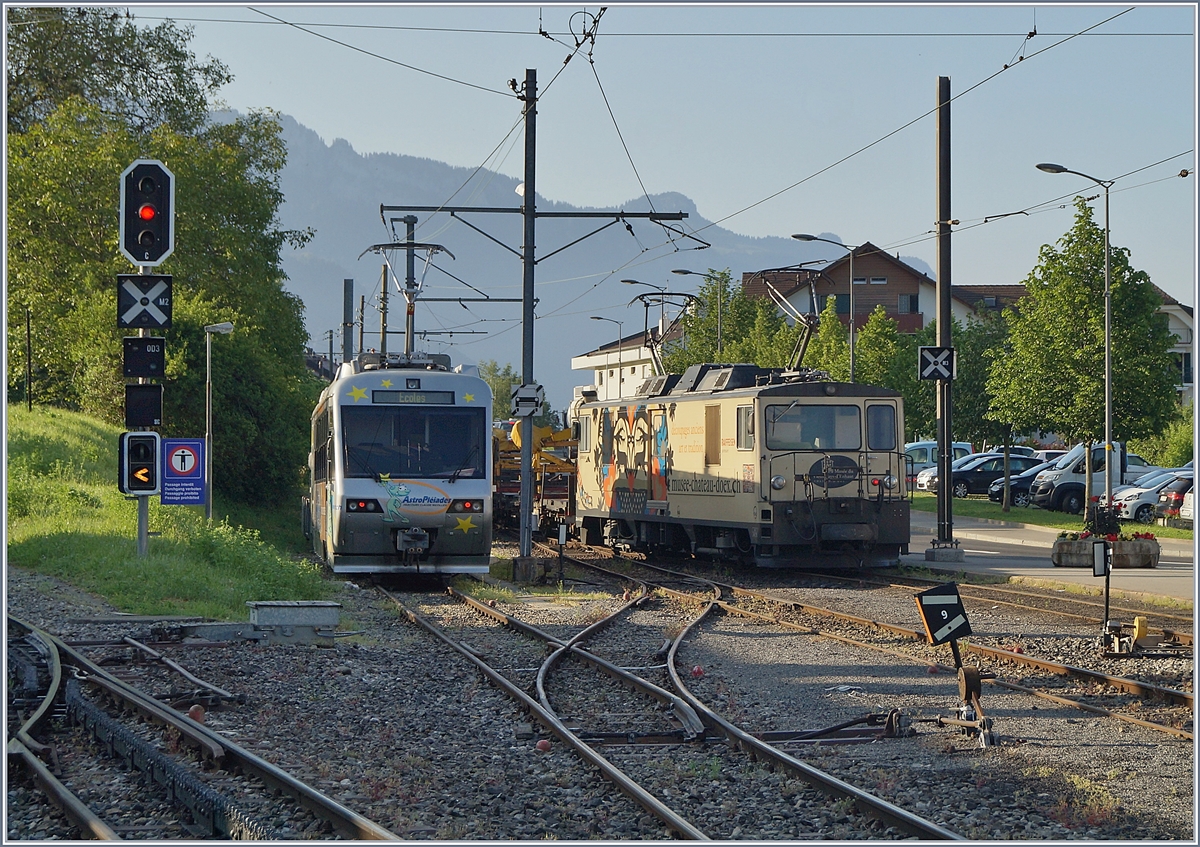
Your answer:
[280,115,932,414]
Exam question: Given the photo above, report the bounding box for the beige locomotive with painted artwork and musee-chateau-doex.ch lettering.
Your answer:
[571,364,911,569]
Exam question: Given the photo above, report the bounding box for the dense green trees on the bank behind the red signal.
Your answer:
[6,8,322,501]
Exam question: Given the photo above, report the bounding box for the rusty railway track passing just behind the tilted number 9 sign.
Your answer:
[547,548,1194,740]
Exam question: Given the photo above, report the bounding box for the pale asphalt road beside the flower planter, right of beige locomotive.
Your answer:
[902,510,1196,600]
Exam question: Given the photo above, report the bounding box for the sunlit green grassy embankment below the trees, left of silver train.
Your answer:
[7,406,328,620]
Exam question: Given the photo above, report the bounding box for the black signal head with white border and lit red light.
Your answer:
[120,158,175,266]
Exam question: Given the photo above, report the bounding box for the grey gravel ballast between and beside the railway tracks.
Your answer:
[7,554,1195,841]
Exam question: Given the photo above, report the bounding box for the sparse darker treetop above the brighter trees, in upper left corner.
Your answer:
[5,6,233,133]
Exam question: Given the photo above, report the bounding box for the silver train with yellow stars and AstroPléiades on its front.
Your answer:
[301,353,493,575]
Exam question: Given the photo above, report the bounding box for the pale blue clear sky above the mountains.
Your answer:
[126,2,1198,367]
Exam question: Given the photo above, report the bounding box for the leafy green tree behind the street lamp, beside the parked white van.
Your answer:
[986,198,1177,443]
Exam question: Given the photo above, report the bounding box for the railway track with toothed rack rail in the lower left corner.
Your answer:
[7,615,397,840]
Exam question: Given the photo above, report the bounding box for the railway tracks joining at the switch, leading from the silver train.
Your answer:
[379,580,958,840]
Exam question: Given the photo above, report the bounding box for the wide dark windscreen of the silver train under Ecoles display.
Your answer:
[342,406,490,479]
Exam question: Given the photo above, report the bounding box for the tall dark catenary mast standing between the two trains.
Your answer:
[520,68,538,557]
